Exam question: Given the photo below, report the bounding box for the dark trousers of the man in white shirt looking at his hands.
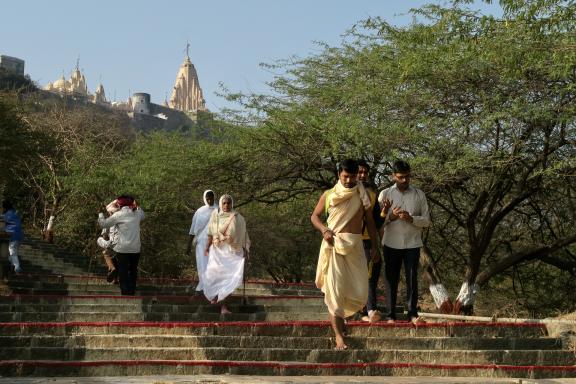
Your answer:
[384,246,420,320]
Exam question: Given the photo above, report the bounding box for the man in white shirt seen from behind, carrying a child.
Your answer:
[98,195,144,296]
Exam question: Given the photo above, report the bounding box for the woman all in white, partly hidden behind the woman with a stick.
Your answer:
[186,189,218,291]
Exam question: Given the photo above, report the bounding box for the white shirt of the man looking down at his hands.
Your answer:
[378,184,431,249]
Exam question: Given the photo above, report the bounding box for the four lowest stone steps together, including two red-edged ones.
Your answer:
[0,321,576,378]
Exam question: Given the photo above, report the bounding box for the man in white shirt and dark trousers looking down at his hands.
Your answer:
[378,160,431,324]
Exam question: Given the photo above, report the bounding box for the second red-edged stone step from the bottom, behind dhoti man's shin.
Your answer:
[0,321,557,341]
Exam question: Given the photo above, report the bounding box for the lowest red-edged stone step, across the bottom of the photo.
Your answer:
[0,360,576,379]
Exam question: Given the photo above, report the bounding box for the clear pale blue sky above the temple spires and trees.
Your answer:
[0,0,499,112]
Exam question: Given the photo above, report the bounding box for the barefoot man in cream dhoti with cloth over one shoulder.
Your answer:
[310,159,378,349]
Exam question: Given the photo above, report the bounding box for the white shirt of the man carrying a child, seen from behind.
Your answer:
[98,207,144,253]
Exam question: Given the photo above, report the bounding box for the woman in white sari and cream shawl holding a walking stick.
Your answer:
[204,195,250,313]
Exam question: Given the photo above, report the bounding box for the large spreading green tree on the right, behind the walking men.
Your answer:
[222,1,576,314]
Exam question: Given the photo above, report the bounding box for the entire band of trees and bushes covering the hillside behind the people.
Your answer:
[0,0,576,316]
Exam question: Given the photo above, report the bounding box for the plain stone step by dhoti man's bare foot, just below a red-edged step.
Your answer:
[0,334,565,357]
